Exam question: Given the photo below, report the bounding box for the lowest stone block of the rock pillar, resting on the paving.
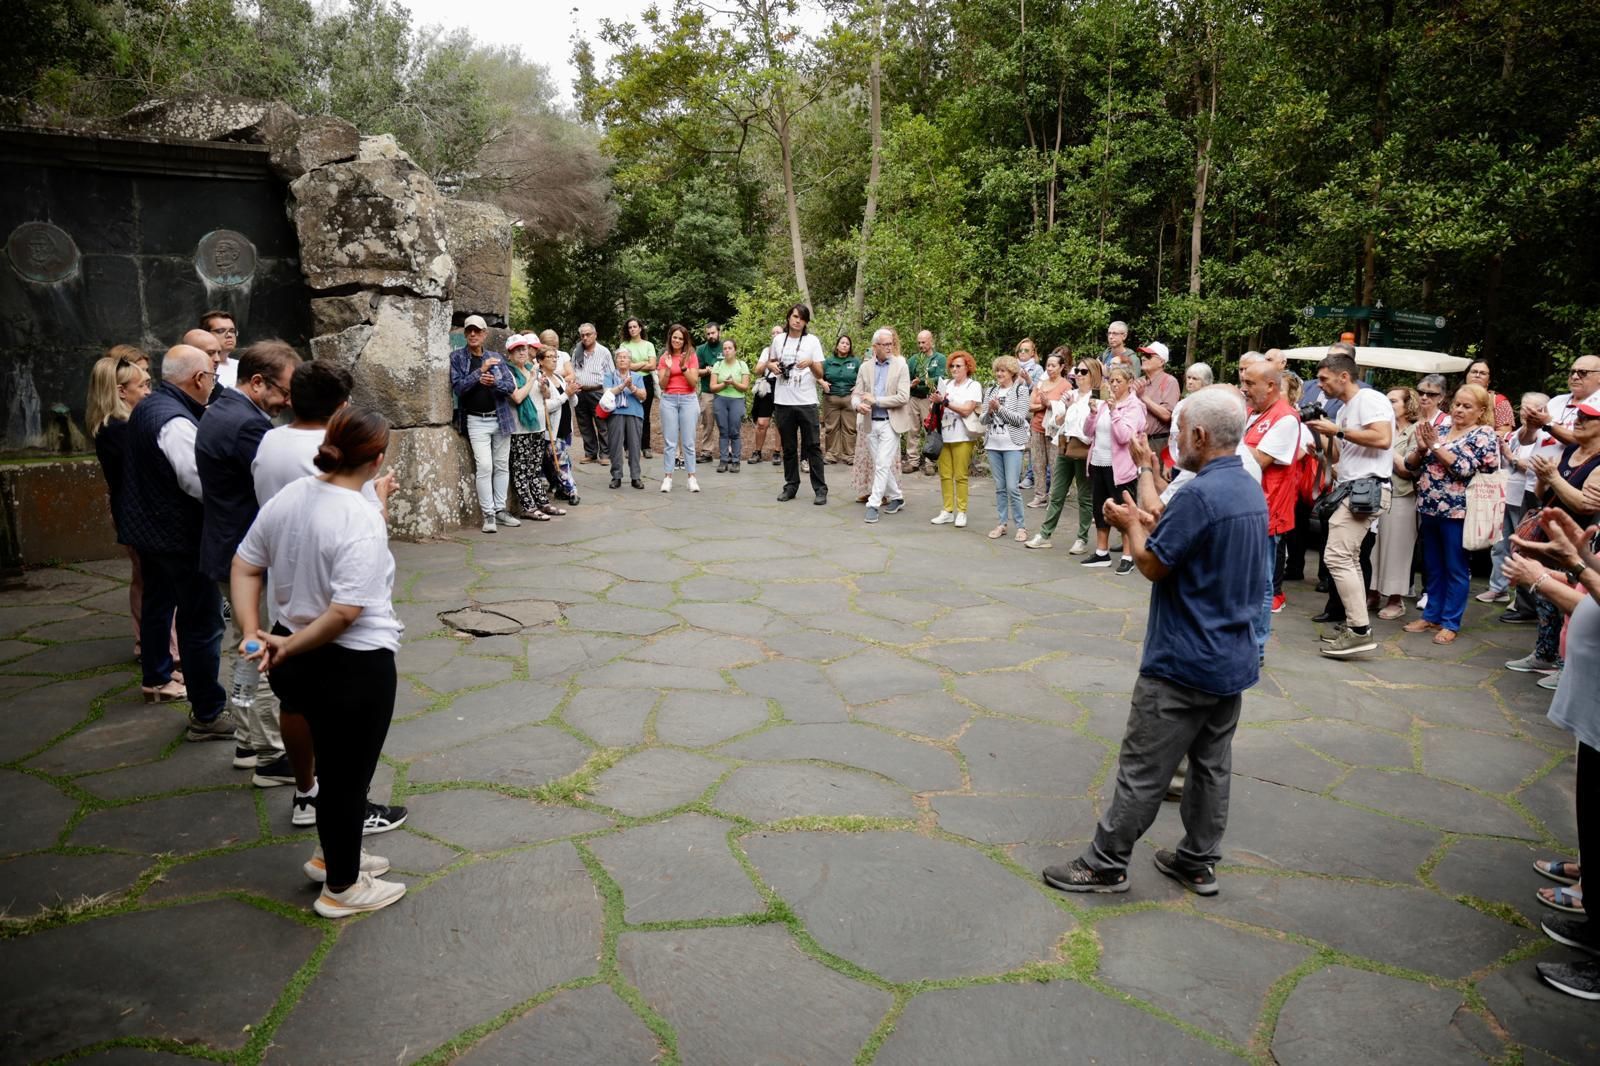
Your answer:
[366,426,478,539]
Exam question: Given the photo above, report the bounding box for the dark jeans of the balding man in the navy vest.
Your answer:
[139,551,227,722]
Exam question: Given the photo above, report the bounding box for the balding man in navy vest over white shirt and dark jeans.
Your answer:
[122,344,235,741]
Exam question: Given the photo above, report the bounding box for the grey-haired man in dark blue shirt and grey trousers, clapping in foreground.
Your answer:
[1045,386,1267,896]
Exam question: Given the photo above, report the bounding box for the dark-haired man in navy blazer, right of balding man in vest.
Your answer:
[195,341,301,789]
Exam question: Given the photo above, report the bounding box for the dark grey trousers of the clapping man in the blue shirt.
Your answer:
[1083,674,1242,874]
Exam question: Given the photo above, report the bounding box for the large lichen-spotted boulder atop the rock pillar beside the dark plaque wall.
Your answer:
[290,154,456,298]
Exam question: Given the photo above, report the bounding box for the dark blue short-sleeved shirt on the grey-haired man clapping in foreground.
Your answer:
[1139,455,1267,696]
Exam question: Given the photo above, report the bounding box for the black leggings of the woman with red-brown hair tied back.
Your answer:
[267,626,395,890]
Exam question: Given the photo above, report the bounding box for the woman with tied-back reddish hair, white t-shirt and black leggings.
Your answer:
[232,407,405,917]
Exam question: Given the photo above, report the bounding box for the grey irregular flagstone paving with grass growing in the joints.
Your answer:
[0,466,1600,1066]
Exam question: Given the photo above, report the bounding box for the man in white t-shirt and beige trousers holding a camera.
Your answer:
[1306,341,1395,659]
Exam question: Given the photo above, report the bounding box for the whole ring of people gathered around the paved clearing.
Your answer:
[88,304,1600,988]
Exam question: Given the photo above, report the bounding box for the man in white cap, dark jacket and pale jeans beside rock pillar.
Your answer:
[450,315,518,533]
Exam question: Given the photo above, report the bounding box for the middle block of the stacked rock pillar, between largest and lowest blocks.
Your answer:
[310,296,451,427]
